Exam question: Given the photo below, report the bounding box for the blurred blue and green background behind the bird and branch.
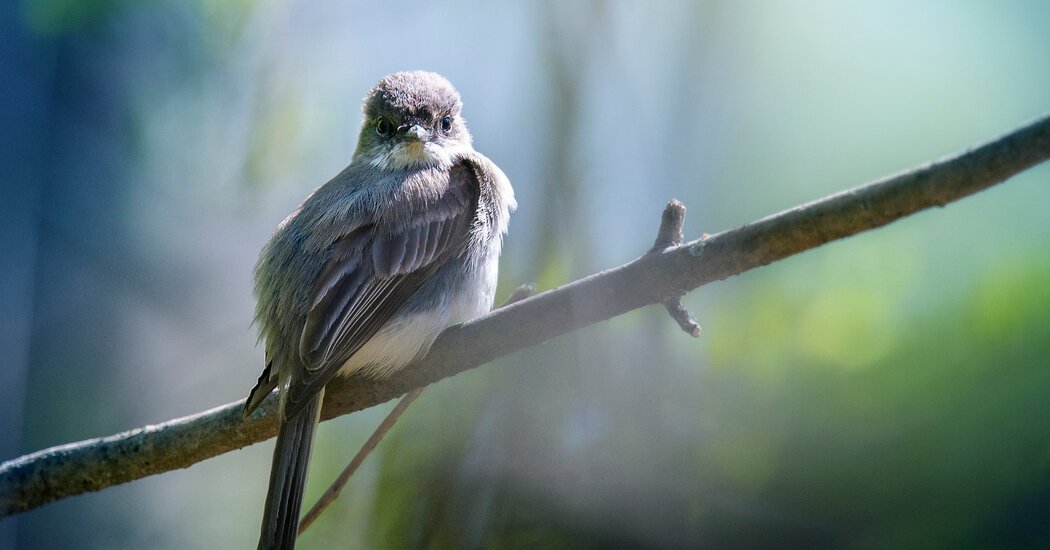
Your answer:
[0,0,1050,549]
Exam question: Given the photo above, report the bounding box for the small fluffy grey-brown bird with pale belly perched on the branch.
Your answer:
[245,71,517,548]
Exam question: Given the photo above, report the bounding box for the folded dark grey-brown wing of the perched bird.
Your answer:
[285,164,480,416]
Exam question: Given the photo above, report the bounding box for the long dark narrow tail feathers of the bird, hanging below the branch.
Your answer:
[258,389,324,550]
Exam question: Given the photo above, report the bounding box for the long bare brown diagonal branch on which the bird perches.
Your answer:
[0,115,1050,516]
